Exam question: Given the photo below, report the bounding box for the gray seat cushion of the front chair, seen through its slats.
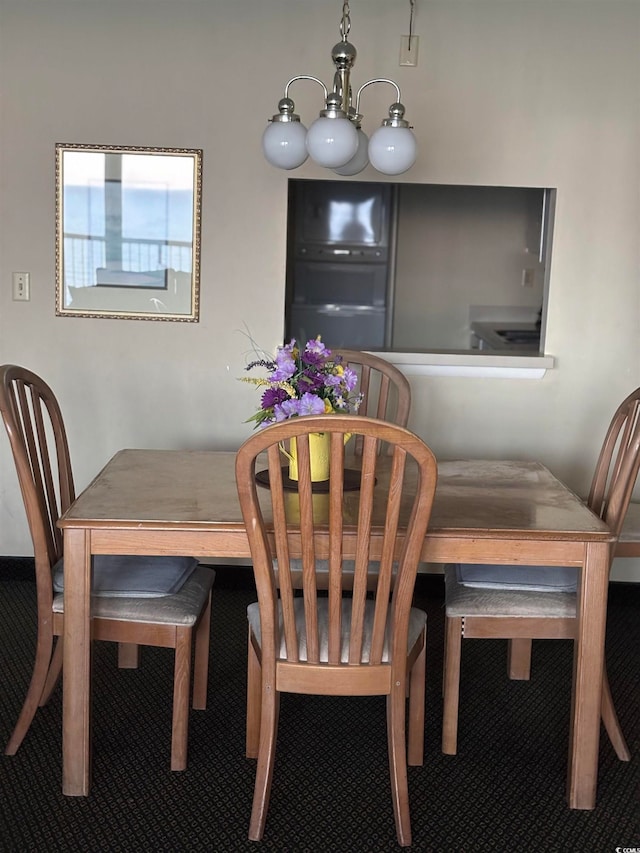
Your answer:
[247,598,427,663]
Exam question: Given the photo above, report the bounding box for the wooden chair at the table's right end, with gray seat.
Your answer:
[442,388,640,761]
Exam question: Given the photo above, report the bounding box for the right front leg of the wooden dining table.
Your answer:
[567,543,609,809]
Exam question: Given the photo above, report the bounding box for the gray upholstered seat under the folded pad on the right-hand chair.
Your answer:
[444,565,576,619]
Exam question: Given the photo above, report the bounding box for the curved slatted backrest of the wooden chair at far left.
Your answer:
[0,365,75,594]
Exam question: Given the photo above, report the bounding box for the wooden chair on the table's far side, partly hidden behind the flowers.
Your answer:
[331,349,411,455]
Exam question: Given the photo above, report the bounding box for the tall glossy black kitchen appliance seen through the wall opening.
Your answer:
[285,181,391,349]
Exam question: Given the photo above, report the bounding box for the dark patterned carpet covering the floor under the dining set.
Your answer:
[0,559,640,853]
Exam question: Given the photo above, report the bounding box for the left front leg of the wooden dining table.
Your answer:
[62,528,91,797]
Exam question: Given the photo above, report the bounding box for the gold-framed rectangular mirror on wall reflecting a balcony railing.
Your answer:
[56,143,202,322]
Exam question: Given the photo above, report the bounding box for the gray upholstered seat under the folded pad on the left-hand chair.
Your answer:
[53,566,216,625]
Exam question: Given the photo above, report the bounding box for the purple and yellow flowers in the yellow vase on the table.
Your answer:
[242,337,362,427]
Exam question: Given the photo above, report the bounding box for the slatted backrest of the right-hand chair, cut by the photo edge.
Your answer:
[588,388,640,536]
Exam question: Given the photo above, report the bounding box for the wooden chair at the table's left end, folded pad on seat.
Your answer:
[0,365,215,770]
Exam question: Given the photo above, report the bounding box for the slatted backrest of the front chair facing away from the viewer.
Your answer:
[236,415,437,677]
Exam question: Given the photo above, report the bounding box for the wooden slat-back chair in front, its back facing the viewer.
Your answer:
[236,415,437,846]
